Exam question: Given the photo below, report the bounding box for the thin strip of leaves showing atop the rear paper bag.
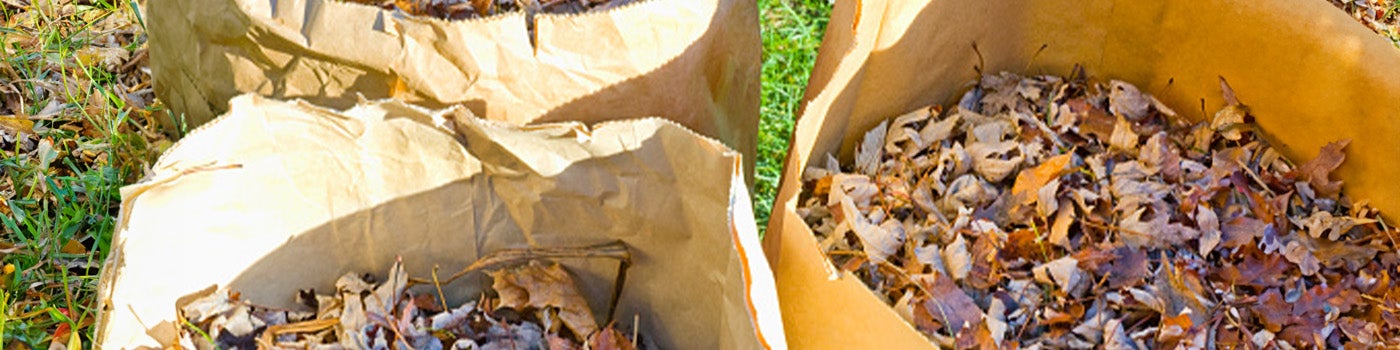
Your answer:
[349,0,633,20]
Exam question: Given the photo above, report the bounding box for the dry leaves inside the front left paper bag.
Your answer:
[176,244,638,350]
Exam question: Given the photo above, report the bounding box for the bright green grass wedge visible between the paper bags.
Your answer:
[753,0,832,231]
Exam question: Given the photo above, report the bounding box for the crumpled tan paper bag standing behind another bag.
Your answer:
[148,0,762,178]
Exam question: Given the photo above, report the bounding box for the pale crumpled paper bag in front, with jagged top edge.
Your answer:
[97,95,785,349]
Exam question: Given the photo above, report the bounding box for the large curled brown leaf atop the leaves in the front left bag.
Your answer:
[490,262,598,335]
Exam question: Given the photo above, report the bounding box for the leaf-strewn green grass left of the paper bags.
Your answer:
[0,0,161,349]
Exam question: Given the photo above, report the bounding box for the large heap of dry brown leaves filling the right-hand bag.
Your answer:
[799,73,1400,349]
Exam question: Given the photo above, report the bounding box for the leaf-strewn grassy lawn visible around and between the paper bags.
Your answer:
[0,0,1400,349]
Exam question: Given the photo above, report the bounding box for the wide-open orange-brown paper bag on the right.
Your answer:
[764,0,1400,349]
